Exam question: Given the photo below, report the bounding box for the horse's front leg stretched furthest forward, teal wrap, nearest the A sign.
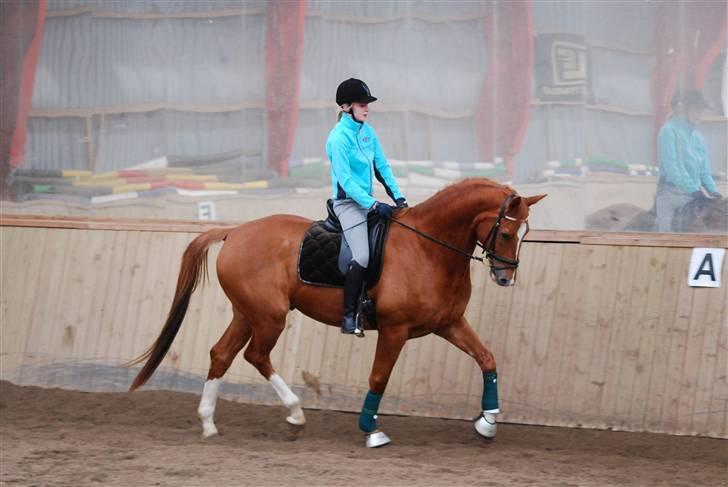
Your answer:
[435,317,500,438]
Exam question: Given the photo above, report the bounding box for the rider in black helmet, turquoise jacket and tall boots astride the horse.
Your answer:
[326,78,407,334]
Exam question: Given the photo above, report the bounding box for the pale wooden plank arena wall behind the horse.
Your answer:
[0,216,728,438]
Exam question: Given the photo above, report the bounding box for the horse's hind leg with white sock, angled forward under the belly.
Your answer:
[244,315,306,426]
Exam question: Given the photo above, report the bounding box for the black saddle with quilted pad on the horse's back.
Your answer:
[298,200,389,289]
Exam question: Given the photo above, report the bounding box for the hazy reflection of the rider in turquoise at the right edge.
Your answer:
[655,90,723,232]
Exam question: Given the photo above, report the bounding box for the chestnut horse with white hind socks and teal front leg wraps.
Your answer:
[130,179,545,447]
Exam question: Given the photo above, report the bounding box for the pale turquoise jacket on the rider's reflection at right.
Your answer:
[657,116,718,193]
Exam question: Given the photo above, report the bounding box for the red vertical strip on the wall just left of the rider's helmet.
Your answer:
[265,0,306,176]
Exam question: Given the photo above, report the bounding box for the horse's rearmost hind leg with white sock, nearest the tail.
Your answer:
[197,311,251,438]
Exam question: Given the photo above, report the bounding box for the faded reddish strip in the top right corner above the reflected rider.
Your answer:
[652,0,726,165]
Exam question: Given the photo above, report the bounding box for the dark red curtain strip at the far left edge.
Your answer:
[0,0,46,194]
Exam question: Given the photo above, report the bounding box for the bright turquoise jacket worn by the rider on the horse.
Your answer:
[326,113,403,209]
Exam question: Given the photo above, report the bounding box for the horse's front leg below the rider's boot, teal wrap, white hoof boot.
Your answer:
[359,326,409,448]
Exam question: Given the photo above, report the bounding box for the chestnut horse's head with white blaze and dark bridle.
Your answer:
[475,193,546,286]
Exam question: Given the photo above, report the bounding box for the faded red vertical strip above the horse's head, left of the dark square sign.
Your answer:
[476,0,533,177]
